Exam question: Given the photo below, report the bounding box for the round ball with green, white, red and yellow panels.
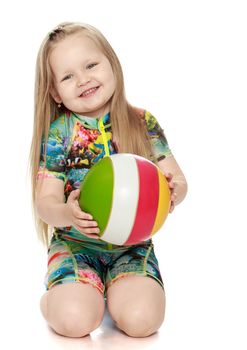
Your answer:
[79,153,170,246]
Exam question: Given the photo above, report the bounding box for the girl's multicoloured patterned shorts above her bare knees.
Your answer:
[45,235,163,294]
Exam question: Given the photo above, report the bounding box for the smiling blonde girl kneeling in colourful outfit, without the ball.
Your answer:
[31,23,187,337]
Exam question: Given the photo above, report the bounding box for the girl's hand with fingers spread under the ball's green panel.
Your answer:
[66,189,100,239]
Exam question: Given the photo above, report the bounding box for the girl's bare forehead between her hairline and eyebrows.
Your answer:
[50,33,104,68]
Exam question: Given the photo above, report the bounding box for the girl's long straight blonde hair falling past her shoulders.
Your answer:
[30,22,153,245]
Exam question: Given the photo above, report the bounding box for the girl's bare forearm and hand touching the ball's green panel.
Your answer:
[35,178,99,238]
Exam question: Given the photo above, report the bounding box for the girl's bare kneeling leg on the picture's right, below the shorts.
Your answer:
[107,276,165,337]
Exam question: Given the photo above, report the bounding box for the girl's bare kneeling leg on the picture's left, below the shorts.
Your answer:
[40,283,105,337]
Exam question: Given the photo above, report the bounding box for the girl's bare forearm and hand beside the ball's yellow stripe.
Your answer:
[158,156,187,211]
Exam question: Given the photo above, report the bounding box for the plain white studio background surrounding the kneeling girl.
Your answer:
[0,0,247,350]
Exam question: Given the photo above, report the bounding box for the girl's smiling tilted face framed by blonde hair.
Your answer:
[50,33,116,117]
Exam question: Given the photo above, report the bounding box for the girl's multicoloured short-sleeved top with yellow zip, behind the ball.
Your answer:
[38,110,171,246]
